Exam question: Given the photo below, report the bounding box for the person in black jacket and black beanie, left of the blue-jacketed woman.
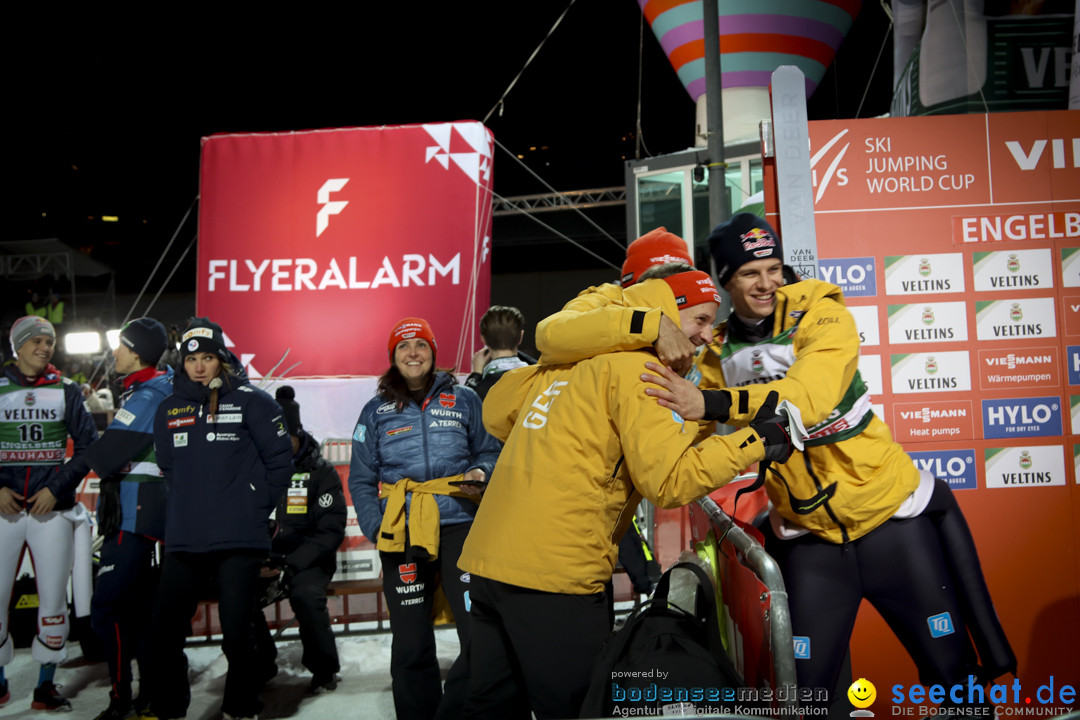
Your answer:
[255,385,347,694]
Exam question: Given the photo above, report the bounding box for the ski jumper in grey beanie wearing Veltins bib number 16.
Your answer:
[0,315,97,710]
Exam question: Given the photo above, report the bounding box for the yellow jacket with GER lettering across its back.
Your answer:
[459,281,765,595]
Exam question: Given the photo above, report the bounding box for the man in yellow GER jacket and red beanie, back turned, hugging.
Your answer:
[459,266,792,718]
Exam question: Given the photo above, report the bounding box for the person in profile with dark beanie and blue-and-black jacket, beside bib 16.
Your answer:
[75,317,173,720]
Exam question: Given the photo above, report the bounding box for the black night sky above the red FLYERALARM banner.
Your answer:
[4,0,892,291]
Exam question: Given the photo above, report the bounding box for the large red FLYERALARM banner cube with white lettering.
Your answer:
[197,122,494,377]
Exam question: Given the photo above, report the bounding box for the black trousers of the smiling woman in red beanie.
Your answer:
[379,522,472,720]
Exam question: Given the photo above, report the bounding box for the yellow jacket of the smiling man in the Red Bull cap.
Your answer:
[537,280,919,543]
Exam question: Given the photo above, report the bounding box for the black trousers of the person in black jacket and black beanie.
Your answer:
[255,567,341,677]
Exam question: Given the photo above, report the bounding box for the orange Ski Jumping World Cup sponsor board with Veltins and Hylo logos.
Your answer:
[766,111,1080,694]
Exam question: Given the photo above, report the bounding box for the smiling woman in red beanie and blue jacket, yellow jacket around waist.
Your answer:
[349,317,500,720]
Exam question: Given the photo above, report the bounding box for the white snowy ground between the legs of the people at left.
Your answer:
[0,628,459,720]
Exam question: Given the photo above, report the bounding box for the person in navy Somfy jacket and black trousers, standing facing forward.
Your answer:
[150,317,293,720]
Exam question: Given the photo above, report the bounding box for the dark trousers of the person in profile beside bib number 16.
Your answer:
[90,532,160,701]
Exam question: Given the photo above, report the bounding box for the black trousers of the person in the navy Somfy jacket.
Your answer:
[150,549,266,720]
